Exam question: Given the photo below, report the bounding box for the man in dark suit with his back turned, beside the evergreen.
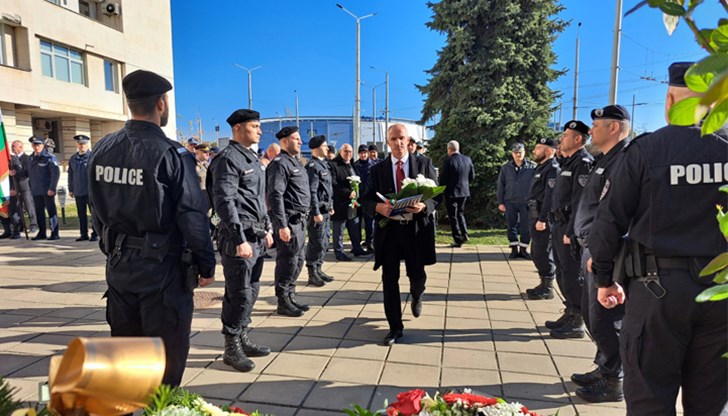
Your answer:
[440,140,475,247]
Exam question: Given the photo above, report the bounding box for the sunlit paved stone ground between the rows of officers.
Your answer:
[0,232,680,416]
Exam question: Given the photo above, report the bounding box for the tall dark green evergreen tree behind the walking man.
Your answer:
[418,0,567,226]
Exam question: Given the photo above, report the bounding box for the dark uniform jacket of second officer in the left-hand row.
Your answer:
[206,141,271,246]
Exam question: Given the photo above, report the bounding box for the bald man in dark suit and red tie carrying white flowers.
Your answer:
[361,124,436,345]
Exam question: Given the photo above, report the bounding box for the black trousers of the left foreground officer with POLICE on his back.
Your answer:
[106,254,193,386]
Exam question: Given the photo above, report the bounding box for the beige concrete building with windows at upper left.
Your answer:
[0,0,176,161]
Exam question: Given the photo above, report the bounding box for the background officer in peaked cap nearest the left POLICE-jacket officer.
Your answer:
[68,134,99,241]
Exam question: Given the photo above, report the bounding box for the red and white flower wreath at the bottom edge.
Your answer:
[345,389,538,416]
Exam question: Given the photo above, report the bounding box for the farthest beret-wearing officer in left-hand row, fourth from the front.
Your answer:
[306,135,334,287]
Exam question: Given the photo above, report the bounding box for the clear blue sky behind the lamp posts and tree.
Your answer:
[172,0,725,140]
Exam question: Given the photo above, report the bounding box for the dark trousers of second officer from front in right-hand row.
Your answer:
[581,248,624,378]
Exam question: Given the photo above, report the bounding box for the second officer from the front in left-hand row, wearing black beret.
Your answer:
[206,109,273,371]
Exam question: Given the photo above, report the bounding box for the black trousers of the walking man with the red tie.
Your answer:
[382,221,427,331]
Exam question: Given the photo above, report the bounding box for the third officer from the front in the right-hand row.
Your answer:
[546,120,594,339]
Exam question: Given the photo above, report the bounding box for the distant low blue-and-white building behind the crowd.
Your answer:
[259,116,432,158]
